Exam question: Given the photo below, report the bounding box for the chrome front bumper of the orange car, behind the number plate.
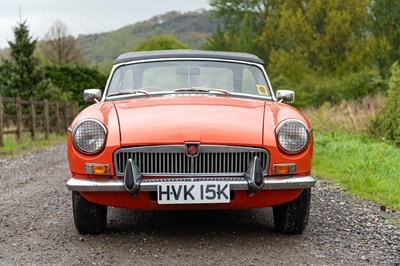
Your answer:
[67,176,316,192]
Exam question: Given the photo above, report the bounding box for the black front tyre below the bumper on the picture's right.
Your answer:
[273,188,311,235]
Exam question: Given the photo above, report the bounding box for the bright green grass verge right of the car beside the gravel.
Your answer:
[312,131,400,210]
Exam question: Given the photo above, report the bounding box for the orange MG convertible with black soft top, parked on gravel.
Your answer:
[67,50,316,234]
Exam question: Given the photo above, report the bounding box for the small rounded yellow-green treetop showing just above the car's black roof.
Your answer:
[135,35,188,51]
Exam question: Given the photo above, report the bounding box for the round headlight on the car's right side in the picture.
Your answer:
[276,119,310,153]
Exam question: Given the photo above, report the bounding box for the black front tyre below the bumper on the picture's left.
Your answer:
[72,191,107,234]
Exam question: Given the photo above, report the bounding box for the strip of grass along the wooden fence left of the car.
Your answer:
[0,133,67,158]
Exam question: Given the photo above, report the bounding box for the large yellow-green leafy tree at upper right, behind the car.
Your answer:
[263,0,384,76]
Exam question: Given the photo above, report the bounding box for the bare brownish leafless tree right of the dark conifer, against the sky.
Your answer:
[39,20,83,65]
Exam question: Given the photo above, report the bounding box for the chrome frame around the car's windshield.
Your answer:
[101,57,276,102]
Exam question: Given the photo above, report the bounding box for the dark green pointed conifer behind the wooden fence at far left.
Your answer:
[0,21,52,99]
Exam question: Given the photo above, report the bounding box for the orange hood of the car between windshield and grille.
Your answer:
[114,96,265,146]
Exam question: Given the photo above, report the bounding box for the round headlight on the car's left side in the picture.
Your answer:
[72,119,107,154]
